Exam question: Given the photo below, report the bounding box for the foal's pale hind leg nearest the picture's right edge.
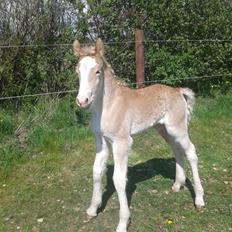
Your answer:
[166,125,204,207]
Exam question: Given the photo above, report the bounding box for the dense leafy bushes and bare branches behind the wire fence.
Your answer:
[0,0,232,100]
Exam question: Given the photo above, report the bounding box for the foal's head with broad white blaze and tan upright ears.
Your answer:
[73,39,104,108]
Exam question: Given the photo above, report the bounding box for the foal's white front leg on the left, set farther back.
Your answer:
[87,136,109,217]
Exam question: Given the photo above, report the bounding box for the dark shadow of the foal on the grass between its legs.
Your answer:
[98,158,195,213]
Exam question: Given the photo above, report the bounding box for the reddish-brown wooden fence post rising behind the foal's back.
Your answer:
[135,29,144,88]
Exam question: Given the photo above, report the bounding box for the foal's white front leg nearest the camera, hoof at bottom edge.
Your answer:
[113,137,132,232]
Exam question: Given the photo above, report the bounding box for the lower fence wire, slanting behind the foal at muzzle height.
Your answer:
[0,73,232,101]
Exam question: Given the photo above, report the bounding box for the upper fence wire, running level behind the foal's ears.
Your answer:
[0,39,232,49]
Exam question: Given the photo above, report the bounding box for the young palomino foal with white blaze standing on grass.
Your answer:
[73,39,204,232]
